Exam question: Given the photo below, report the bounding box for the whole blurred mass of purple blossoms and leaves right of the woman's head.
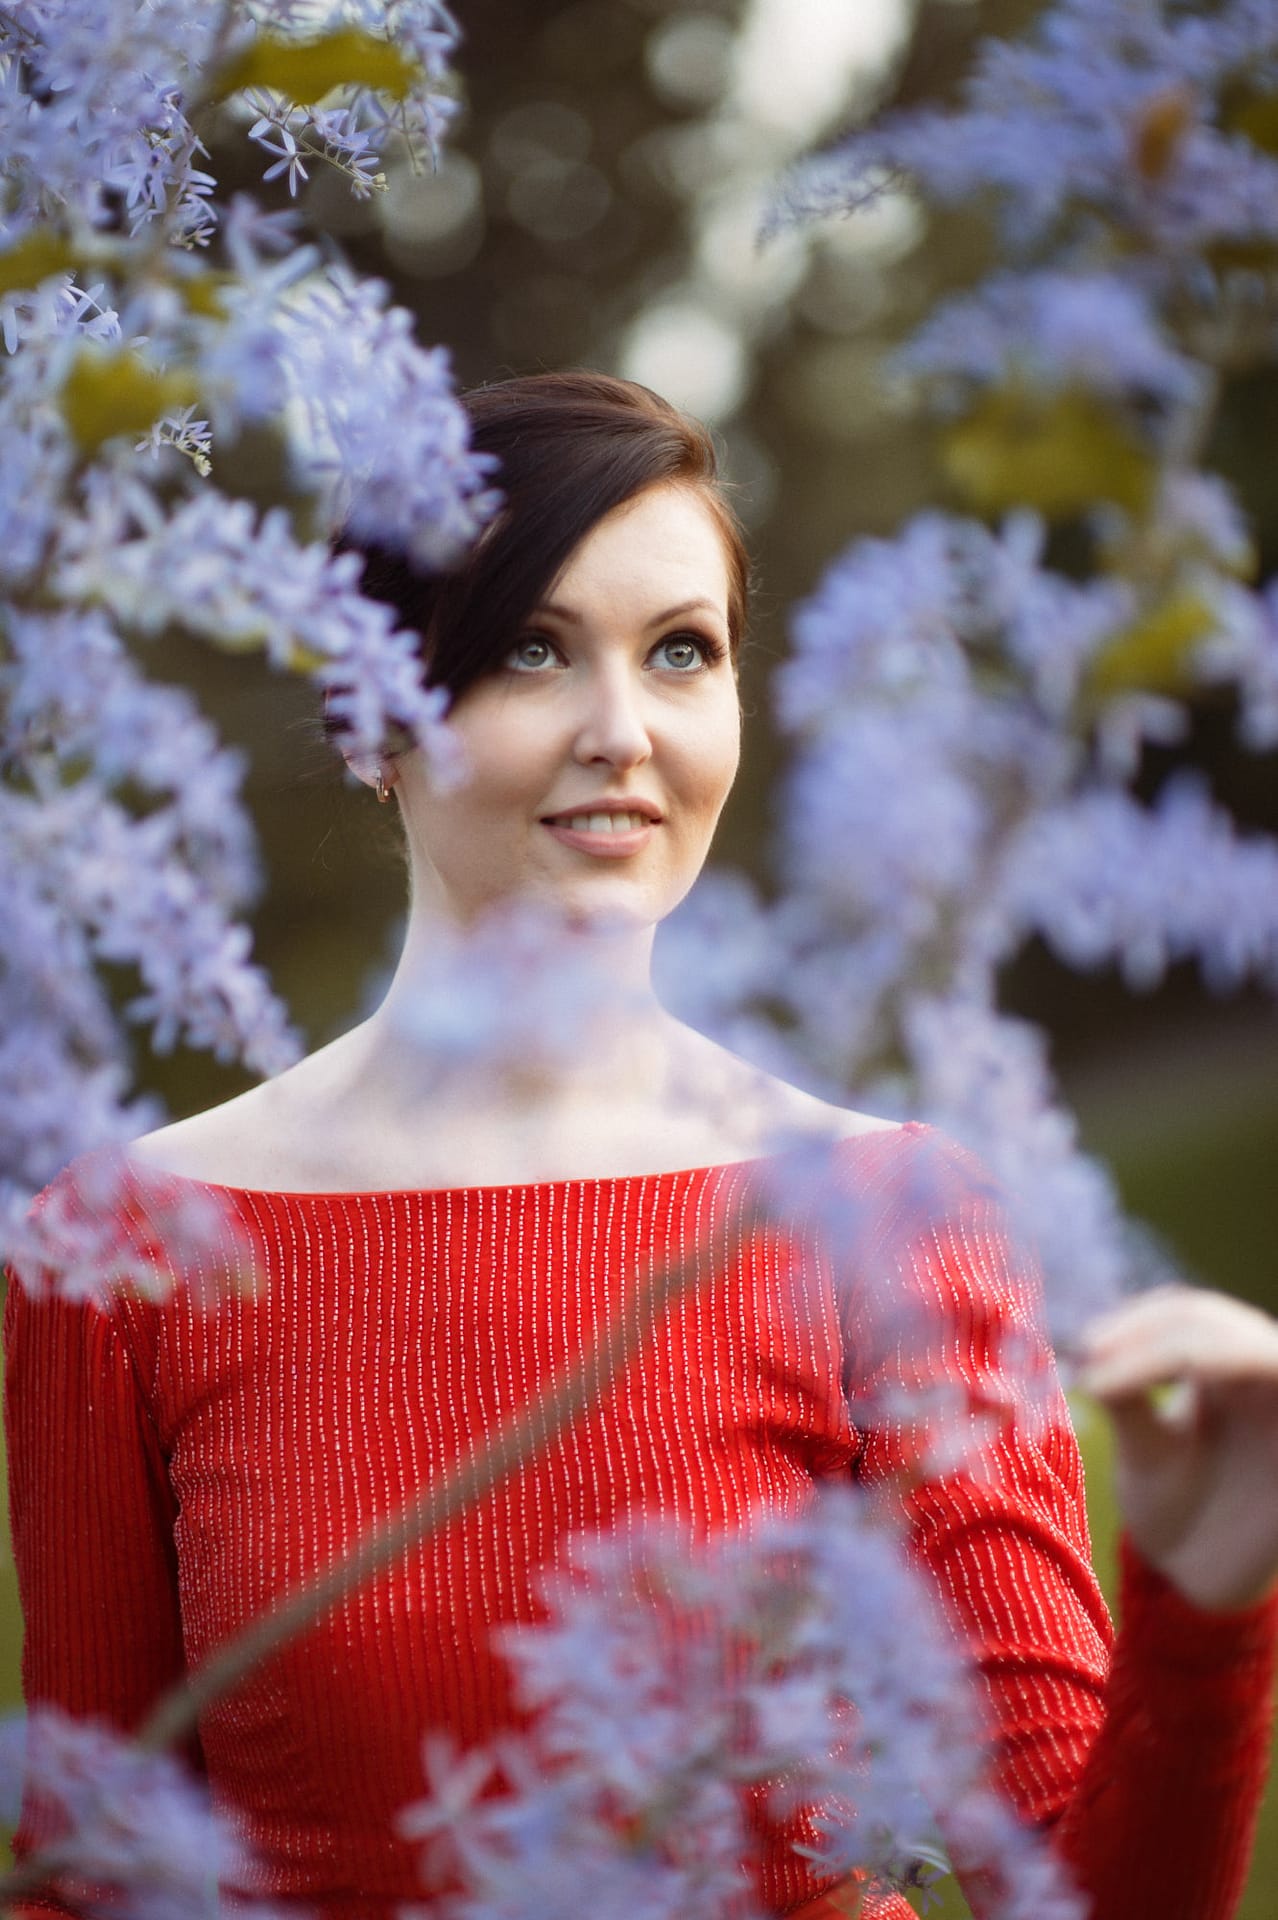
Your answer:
[740,15,1278,1332]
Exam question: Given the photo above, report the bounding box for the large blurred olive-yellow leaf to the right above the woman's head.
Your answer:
[940,388,1155,520]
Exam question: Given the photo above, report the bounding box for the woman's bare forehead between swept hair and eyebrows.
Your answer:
[547,486,729,616]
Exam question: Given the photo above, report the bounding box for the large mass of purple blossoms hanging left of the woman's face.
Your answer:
[0,0,495,1265]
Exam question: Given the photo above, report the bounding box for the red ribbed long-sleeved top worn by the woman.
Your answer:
[6,1127,1276,1920]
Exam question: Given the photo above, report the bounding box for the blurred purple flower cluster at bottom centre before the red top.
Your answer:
[399,1490,1080,1920]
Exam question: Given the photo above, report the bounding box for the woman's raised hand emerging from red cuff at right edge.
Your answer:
[1077,1286,1278,1611]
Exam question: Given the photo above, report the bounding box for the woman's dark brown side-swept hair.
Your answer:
[342,372,750,714]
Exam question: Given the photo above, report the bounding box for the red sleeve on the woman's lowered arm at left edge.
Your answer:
[4,1279,196,1910]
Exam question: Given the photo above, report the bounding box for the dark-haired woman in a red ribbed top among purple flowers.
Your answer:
[6,374,1278,1920]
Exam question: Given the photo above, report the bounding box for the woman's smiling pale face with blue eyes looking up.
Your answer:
[395,484,741,925]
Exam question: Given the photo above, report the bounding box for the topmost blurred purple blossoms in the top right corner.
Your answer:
[775,0,1278,263]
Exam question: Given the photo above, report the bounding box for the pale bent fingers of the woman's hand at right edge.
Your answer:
[1077,1286,1278,1417]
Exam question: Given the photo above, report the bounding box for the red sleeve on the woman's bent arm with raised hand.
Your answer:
[836,1128,1278,1920]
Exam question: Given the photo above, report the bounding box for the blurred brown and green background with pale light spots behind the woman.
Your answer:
[0,0,1278,1920]
